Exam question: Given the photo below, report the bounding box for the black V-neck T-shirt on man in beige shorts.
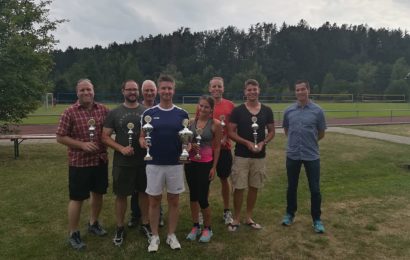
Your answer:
[231,104,274,158]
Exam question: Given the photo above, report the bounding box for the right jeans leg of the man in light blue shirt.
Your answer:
[303,159,322,221]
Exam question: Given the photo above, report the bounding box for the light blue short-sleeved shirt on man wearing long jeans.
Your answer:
[282,101,326,161]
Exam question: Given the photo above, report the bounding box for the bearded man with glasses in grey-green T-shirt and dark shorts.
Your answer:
[102,80,151,246]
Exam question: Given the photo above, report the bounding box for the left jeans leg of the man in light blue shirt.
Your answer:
[286,158,302,217]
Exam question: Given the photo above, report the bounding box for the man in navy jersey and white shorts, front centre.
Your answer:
[140,75,188,252]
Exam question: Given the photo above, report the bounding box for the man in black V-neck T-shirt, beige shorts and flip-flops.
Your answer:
[228,79,275,231]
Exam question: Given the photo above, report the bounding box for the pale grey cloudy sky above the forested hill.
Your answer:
[49,0,410,50]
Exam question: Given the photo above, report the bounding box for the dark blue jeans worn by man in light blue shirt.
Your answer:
[286,157,322,220]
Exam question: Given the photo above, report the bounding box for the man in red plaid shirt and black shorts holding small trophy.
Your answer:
[56,79,108,250]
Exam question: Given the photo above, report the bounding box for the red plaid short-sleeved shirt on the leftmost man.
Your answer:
[56,101,108,167]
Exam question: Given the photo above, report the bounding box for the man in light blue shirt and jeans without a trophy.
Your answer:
[282,80,326,233]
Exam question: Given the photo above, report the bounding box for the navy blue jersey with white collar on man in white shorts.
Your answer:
[141,105,188,165]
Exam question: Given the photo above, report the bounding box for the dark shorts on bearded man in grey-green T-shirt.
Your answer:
[112,165,147,196]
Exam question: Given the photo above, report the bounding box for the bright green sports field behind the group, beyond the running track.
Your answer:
[18,103,410,124]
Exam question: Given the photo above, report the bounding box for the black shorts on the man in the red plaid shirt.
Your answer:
[68,162,108,201]
